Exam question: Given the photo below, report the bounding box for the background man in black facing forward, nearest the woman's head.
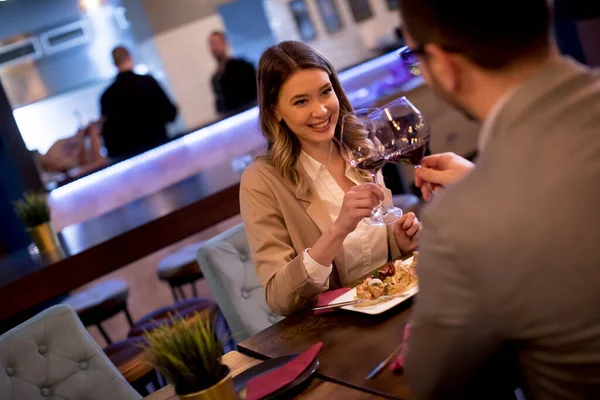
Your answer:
[208,31,257,115]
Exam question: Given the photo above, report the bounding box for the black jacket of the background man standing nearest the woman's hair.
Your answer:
[211,58,257,114]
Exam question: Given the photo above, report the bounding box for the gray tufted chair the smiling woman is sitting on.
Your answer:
[198,224,281,343]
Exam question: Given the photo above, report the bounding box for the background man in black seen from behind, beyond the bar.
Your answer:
[100,47,177,159]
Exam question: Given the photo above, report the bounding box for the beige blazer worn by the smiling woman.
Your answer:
[240,160,400,315]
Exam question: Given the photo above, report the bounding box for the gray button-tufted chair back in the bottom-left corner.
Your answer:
[0,305,141,400]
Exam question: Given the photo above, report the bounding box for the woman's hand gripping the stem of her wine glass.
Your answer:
[334,183,384,236]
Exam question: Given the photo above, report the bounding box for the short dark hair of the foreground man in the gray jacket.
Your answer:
[400,0,552,69]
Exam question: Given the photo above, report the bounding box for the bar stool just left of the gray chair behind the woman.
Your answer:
[157,243,204,302]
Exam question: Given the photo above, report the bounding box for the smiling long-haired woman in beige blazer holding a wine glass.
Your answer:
[240,42,421,315]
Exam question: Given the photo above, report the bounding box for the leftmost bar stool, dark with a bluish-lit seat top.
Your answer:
[63,279,133,345]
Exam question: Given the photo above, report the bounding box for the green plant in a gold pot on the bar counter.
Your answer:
[14,193,60,253]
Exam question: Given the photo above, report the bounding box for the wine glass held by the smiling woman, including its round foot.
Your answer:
[340,108,402,226]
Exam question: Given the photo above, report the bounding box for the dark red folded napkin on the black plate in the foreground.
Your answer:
[246,342,323,400]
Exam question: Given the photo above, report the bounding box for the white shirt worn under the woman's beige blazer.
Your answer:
[299,151,388,285]
